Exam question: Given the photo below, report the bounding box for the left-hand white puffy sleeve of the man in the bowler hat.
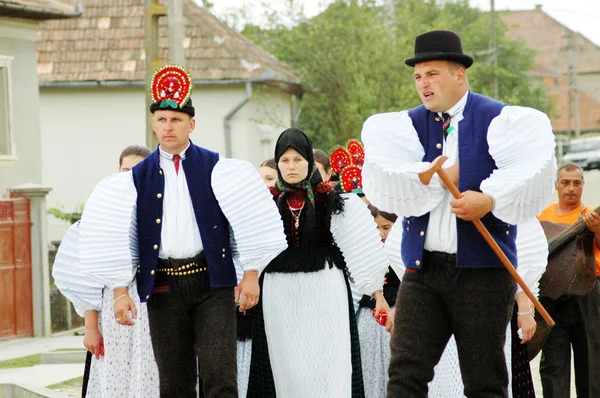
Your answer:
[361,111,445,218]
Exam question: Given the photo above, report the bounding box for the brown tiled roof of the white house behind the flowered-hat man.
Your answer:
[38,0,301,90]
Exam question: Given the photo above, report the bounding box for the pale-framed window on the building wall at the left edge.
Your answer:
[0,55,16,160]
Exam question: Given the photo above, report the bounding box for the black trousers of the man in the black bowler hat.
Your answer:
[387,252,516,398]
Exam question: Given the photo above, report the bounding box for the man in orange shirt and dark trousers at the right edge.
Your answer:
[538,163,600,398]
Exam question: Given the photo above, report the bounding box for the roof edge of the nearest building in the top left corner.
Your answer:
[0,0,79,20]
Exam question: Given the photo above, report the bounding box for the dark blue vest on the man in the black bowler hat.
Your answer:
[402,93,517,270]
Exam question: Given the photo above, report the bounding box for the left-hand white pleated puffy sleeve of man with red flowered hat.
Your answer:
[79,172,139,290]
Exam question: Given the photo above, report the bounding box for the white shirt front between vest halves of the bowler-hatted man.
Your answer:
[425,90,469,253]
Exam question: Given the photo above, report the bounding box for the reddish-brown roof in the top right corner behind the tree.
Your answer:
[499,7,600,75]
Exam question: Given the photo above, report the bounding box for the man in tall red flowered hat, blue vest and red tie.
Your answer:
[80,65,287,398]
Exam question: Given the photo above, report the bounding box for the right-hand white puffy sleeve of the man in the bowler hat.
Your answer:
[480,106,556,224]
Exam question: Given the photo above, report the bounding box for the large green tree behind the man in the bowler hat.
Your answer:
[237,0,551,149]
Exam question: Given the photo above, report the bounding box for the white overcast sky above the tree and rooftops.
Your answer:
[204,0,600,45]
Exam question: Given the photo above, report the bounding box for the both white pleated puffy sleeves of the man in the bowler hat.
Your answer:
[362,101,556,253]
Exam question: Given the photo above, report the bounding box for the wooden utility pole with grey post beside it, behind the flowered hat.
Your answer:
[144,0,185,149]
